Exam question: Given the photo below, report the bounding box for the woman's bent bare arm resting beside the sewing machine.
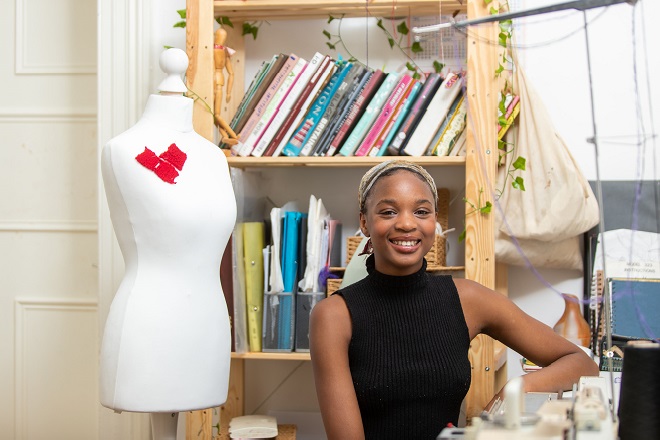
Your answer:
[455,280,598,398]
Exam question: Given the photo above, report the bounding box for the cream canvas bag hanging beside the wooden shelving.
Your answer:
[494,63,599,269]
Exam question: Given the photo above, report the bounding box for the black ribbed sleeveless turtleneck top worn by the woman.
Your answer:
[336,255,471,440]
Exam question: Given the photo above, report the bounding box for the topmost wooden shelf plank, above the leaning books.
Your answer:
[213,0,466,21]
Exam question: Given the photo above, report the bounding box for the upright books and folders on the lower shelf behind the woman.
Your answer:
[221,196,342,352]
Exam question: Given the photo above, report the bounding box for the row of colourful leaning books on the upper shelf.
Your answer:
[230,52,467,157]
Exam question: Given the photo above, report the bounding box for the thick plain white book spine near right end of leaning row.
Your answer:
[403,73,463,156]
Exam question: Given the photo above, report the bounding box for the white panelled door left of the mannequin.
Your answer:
[0,0,99,440]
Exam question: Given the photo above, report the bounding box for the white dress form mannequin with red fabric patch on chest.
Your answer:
[100,49,236,440]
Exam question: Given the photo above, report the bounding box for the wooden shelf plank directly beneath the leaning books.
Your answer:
[227,156,465,168]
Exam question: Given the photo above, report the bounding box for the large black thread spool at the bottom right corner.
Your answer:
[619,341,660,440]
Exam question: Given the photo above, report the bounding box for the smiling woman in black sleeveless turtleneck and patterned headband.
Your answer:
[310,160,598,439]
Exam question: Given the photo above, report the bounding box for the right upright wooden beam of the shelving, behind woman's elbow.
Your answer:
[465,0,499,418]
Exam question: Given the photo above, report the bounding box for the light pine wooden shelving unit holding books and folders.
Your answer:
[186,0,506,440]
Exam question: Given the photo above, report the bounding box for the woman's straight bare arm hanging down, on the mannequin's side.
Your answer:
[309,295,364,440]
